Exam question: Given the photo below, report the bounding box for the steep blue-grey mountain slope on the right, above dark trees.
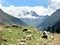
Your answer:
[38,9,60,30]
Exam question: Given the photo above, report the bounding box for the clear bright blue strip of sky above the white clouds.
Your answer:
[1,0,48,7]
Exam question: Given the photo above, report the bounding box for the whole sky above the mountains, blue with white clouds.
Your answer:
[0,0,60,17]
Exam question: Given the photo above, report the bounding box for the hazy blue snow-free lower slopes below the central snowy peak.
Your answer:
[20,15,48,27]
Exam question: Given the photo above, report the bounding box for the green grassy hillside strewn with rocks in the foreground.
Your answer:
[0,26,54,45]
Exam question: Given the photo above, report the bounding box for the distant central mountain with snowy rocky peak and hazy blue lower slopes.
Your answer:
[14,10,48,27]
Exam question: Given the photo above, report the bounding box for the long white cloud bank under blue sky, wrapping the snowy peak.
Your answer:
[0,4,53,18]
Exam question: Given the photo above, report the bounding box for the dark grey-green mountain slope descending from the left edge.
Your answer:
[0,9,27,25]
